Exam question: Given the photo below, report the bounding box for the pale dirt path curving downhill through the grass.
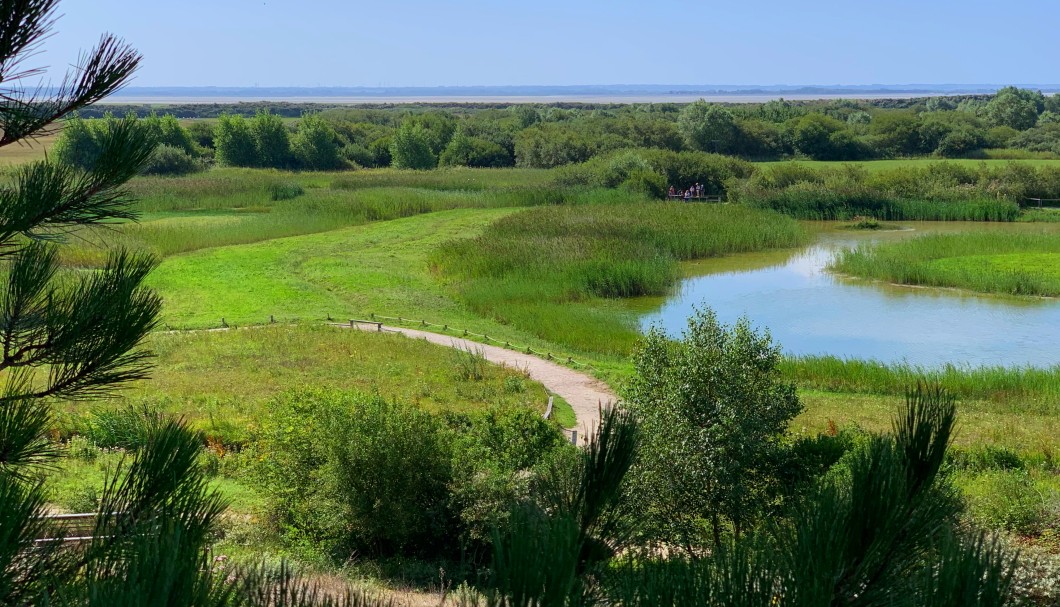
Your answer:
[340,323,618,438]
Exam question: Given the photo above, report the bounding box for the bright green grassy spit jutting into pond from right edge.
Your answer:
[832,229,1060,297]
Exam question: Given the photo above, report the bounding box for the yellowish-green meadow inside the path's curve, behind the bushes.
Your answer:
[59,325,573,444]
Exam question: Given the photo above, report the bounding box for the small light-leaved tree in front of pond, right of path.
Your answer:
[625,310,801,553]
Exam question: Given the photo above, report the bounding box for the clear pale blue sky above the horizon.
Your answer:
[38,0,1060,87]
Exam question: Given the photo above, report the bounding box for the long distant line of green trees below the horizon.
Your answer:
[59,87,1060,185]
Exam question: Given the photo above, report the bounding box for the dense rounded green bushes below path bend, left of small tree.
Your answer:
[257,391,564,557]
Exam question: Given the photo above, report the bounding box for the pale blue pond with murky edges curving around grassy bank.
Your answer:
[640,224,1060,367]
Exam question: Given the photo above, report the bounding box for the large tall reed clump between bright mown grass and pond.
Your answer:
[432,202,809,353]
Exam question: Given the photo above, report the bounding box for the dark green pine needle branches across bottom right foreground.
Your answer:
[485,387,1015,607]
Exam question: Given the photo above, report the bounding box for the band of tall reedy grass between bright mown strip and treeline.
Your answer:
[63,168,580,267]
